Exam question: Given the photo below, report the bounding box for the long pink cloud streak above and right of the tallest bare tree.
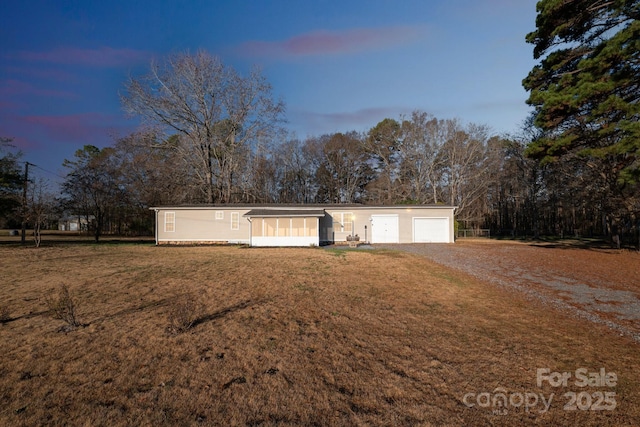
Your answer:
[240,26,423,58]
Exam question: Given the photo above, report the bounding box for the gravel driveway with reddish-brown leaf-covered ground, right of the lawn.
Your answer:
[375,241,640,343]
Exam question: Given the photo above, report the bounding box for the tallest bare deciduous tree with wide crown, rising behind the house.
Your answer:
[121,51,284,203]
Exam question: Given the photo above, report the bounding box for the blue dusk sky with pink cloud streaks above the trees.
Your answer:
[0,0,536,179]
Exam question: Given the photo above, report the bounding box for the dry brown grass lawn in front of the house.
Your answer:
[0,244,640,426]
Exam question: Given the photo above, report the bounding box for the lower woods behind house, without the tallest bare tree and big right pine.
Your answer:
[3,107,637,247]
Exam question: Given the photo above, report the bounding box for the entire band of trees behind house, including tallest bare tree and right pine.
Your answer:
[0,0,640,246]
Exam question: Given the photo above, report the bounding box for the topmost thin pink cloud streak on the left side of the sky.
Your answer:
[16,47,151,67]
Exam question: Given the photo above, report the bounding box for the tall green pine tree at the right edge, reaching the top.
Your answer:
[523,0,640,244]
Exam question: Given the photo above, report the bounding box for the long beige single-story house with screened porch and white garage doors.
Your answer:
[151,204,456,246]
